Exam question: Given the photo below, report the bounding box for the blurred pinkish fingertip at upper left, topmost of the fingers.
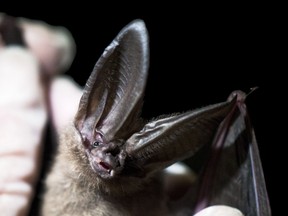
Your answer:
[19,18,76,74]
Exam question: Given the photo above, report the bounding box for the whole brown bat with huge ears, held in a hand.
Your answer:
[41,20,271,216]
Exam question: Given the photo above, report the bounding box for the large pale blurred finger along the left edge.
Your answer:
[0,46,47,215]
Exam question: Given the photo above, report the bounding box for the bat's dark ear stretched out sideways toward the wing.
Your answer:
[123,98,236,176]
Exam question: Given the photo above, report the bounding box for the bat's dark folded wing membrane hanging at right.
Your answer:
[192,92,271,216]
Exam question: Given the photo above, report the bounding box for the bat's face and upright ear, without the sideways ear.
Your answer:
[75,20,149,178]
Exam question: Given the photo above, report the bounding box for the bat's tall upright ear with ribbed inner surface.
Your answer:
[74,20,149,141]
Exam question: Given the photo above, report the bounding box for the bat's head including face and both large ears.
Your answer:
[74,20,233,179]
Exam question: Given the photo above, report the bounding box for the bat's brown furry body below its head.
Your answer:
[42,123,168,216]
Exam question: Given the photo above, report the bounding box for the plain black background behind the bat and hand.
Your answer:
[1,3,287,214]
